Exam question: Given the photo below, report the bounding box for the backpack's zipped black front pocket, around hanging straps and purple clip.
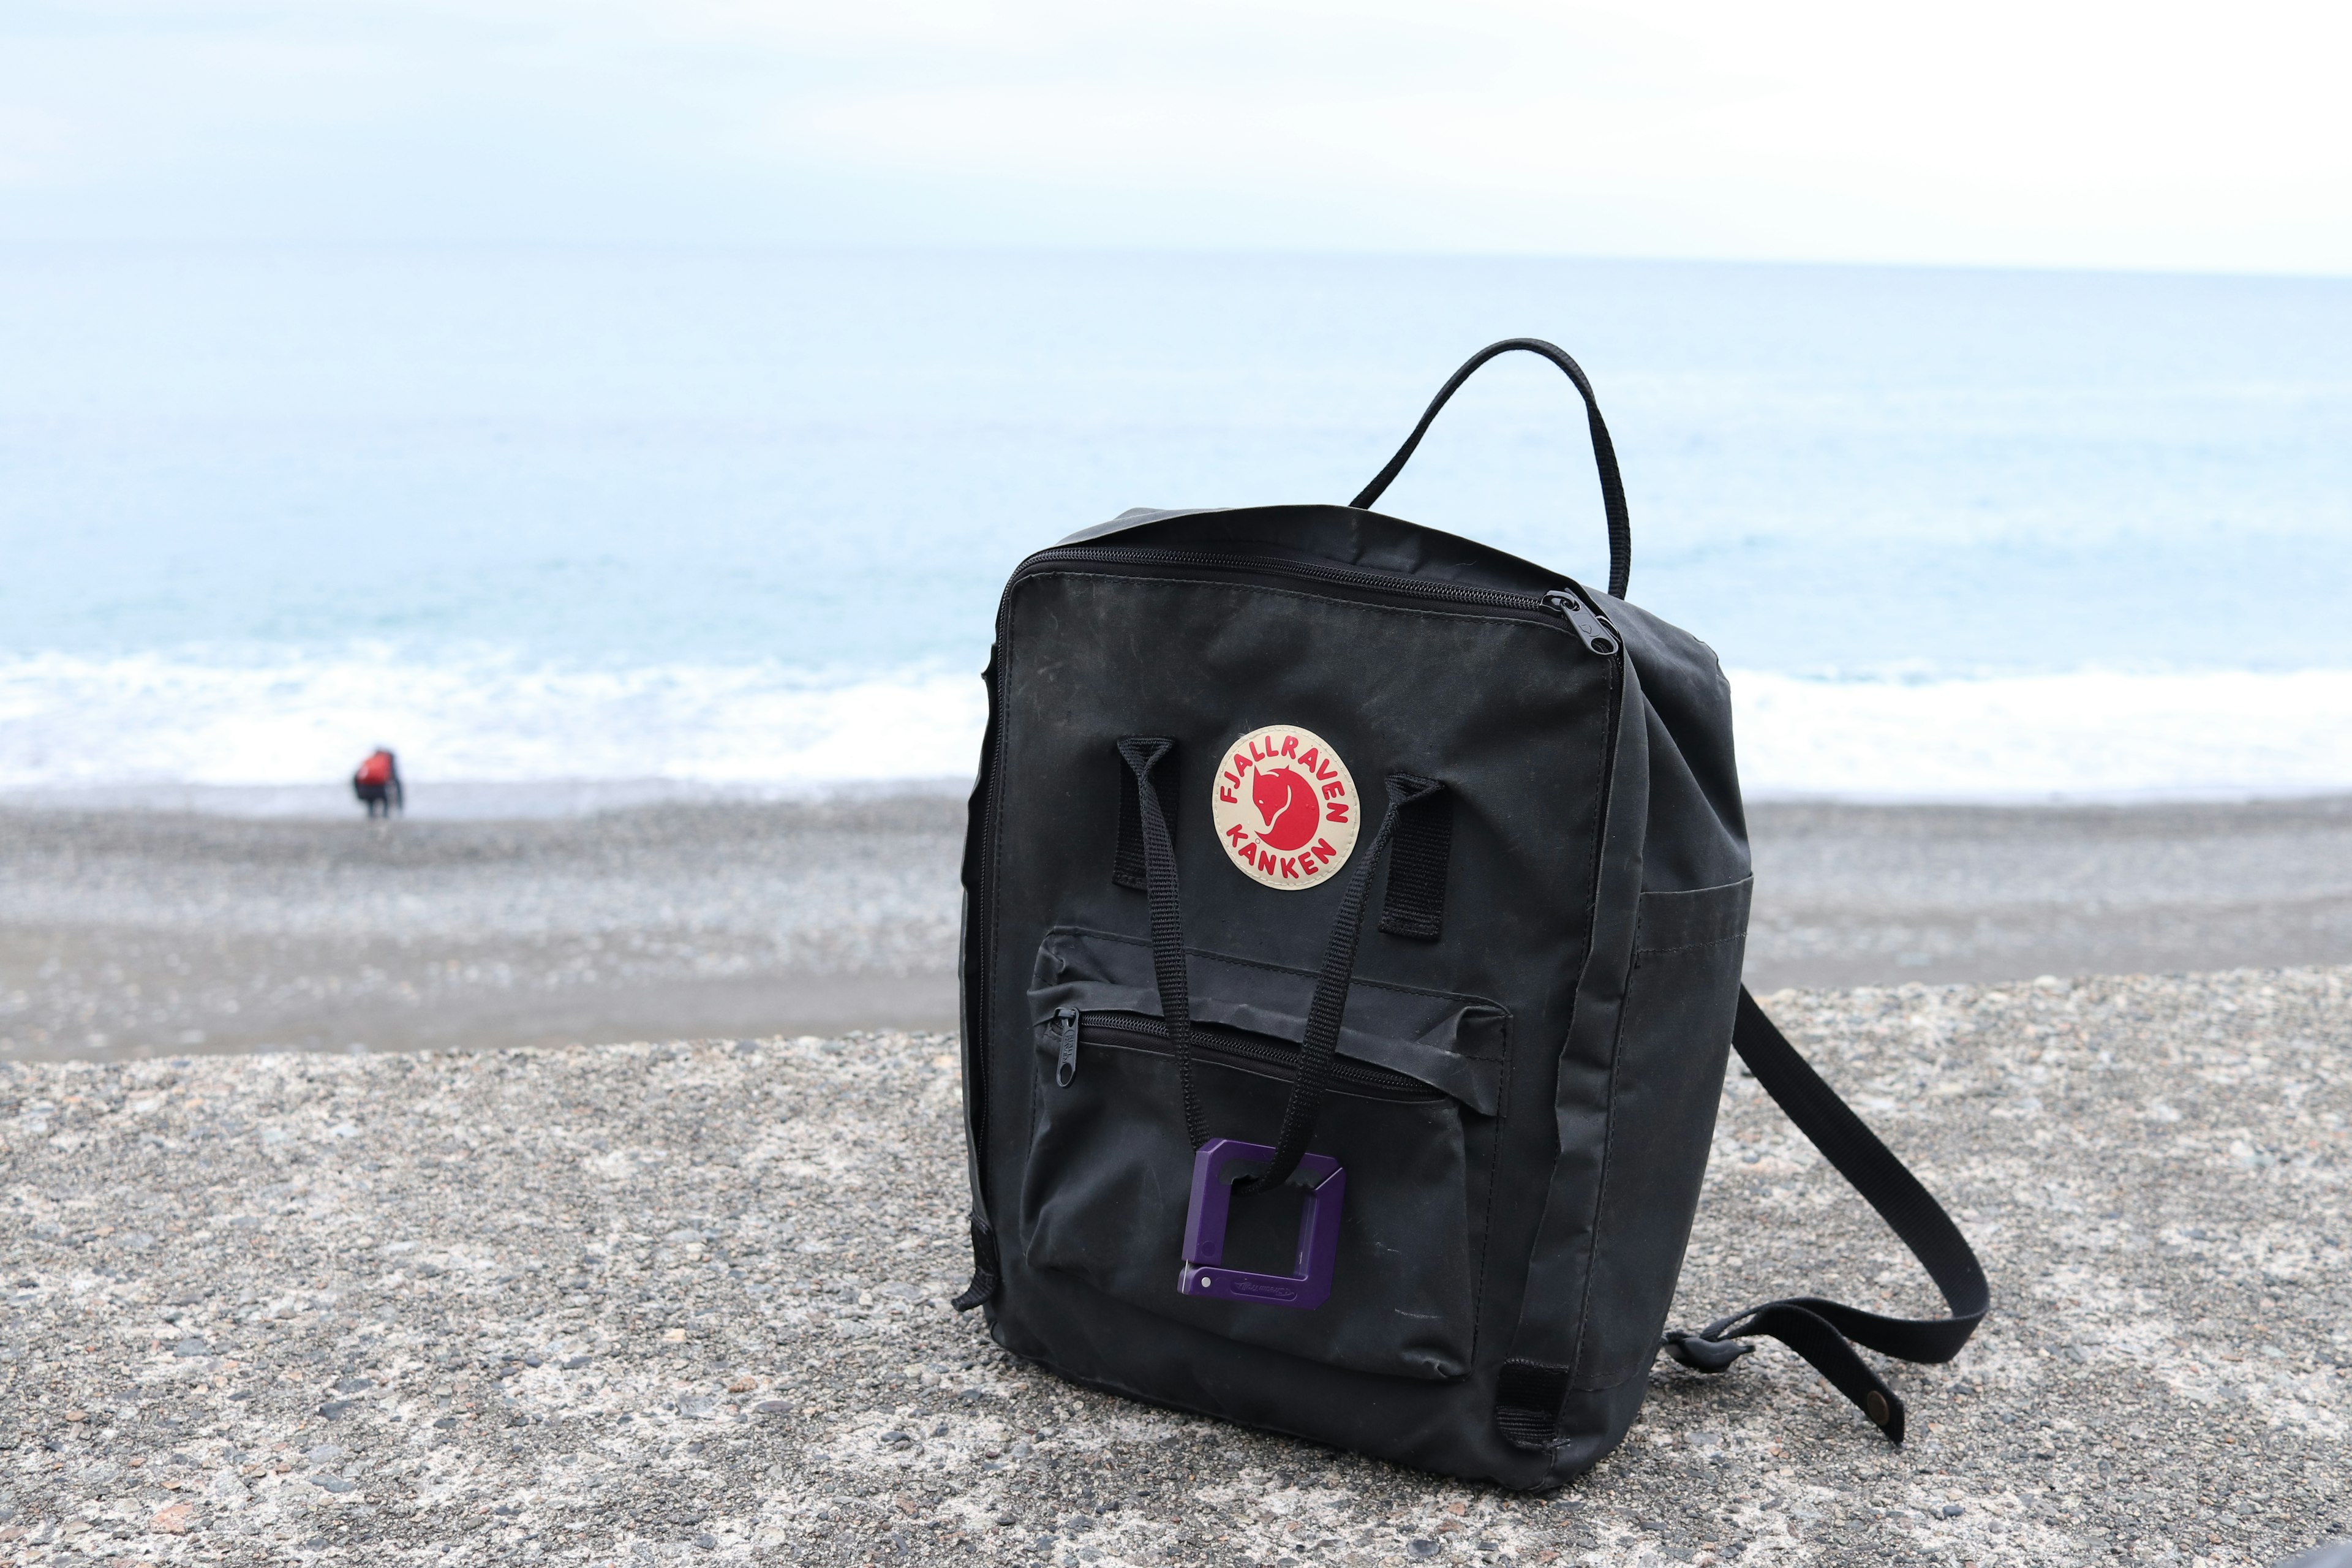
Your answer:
[1021,931,1507,1380]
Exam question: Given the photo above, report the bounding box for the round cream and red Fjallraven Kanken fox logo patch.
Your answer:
[1209,724,1360,891]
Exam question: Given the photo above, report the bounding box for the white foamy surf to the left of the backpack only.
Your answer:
[0,654,988,794]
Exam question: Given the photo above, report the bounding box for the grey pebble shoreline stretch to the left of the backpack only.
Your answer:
[0,794,964,1058]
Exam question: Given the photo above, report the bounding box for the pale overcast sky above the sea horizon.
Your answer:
[0,0,2352,275]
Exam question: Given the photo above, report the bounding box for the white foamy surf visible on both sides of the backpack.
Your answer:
[0,654,2352,813]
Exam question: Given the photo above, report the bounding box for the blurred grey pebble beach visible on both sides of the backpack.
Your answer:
[0,794,2352,1060]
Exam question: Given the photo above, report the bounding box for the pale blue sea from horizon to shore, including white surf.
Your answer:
[0,244,2352,816]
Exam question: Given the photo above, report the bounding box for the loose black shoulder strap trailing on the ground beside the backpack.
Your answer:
[1665,985,1992,1444]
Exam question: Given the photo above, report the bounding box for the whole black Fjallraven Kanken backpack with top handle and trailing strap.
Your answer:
[957,339,1990,1488]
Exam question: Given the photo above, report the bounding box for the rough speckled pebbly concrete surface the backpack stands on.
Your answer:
[0,968,2352,1566]
